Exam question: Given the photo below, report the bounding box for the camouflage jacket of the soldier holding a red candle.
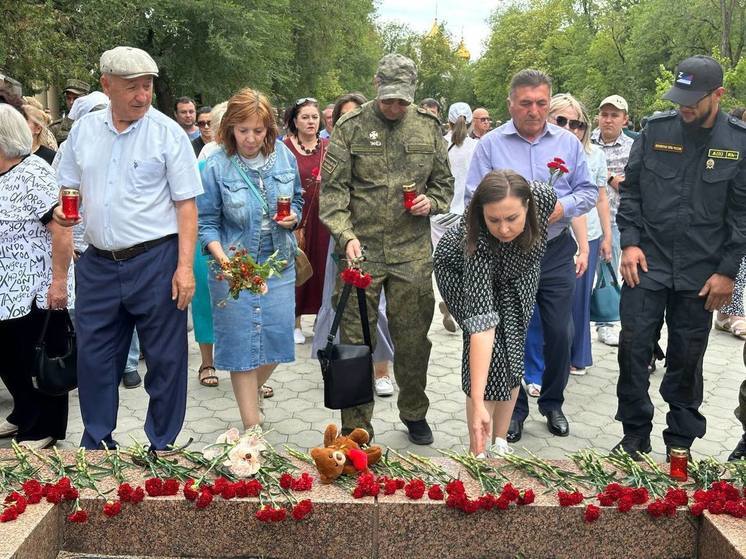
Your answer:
[319,100,453,264]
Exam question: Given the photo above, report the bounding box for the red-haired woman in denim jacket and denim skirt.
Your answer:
[197,89,303,428]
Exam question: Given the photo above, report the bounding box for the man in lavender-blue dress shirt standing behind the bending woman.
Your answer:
[465,69,598,442]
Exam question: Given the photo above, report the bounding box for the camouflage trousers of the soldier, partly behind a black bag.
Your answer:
[334,258,435,436]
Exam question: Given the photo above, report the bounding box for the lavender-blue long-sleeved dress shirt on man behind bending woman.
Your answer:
[465,119,598,239]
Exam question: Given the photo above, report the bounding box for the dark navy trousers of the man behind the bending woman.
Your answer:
[513,231,578,421]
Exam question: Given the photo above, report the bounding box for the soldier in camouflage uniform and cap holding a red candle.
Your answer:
[319,54,453,444]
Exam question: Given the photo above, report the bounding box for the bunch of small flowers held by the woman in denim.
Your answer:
[214,246,287,299]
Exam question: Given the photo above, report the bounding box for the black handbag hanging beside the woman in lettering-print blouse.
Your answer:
[31,309,78,396]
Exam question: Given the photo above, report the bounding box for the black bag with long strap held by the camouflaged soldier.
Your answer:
[317,284,373,410]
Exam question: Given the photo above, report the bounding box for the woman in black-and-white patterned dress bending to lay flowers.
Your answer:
[433,170,557,455]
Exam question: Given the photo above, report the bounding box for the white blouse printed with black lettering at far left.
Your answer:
[0,155,73,320]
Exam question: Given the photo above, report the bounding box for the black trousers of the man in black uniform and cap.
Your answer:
[616,285,712,448]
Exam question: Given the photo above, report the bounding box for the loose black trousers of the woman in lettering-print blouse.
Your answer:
[0,305,68,441]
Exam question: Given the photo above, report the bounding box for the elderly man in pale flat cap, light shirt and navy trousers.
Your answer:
[54,47,202,450]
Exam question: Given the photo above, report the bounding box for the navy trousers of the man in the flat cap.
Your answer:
[75,239,187,450]
